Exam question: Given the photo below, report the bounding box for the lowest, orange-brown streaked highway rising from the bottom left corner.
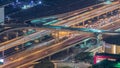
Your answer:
[3,33,93,68]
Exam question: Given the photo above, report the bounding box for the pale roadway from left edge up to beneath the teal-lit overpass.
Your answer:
[0,30,50,51]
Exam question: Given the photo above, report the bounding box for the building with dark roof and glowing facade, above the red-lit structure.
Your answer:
[104,35,120,54]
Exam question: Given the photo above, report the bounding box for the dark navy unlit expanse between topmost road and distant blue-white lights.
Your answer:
[0,0,99,21]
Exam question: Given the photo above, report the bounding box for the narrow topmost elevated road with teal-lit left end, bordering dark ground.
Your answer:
[25,3,105,25]
